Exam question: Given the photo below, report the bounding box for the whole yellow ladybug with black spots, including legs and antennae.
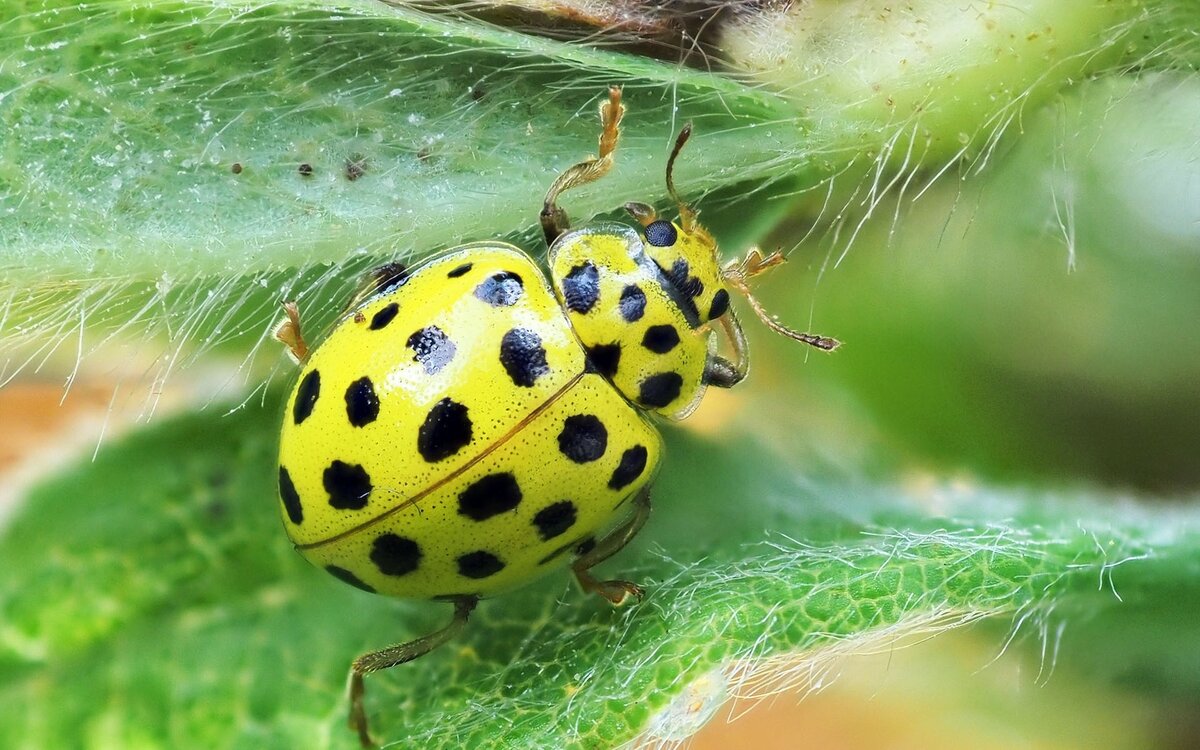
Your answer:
[276,88,838,746]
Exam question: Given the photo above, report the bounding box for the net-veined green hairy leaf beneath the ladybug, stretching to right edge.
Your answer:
[0,398,1200,748]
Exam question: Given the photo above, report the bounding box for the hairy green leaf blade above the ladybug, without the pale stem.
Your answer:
[0,1,793,281]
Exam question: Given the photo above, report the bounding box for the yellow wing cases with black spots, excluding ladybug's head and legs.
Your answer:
[280,242,662,598]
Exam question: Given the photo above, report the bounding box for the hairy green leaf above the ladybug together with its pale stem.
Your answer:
[0,0,1180,289]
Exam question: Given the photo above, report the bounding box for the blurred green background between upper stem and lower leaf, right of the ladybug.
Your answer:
[755,74,1200,494]
